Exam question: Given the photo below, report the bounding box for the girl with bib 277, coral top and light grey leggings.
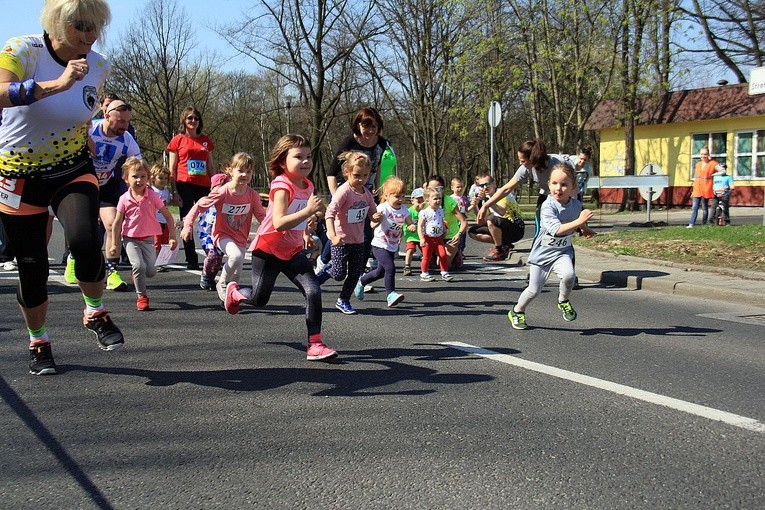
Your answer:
[181,152,266,301]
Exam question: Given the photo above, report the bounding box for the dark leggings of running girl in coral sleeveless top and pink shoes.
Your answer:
[239,250,321,338]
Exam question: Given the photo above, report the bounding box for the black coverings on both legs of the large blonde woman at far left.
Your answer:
[0,182,104,308]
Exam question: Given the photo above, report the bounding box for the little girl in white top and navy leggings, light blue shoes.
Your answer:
[355,176,417,307]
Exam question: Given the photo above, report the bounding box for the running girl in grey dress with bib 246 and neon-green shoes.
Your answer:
[507,164,592,329]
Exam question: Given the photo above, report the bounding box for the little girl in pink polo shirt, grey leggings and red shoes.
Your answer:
[108,157,178,311]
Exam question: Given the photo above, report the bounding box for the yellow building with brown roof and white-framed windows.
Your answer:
[585,84,765,206]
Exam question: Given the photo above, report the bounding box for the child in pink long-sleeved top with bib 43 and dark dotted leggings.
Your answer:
[316,151,382,315]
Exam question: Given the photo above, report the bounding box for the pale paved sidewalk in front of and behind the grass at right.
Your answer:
[502,207,765,308]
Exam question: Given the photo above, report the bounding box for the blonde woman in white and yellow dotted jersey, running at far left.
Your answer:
[0,0,124,375]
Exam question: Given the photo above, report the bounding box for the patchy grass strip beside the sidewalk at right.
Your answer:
[575,225,765,272]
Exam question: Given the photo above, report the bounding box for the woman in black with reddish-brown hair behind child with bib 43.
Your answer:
[321,106,393,263]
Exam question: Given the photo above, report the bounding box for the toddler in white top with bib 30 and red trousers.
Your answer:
[417,188,454,282]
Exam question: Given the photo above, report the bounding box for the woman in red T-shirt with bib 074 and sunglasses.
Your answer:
[167,106,215,269]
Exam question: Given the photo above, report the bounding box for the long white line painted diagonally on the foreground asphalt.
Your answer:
[441,342,765,434]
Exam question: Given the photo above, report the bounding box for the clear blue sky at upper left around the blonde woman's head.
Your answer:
[0,0,256,72]
